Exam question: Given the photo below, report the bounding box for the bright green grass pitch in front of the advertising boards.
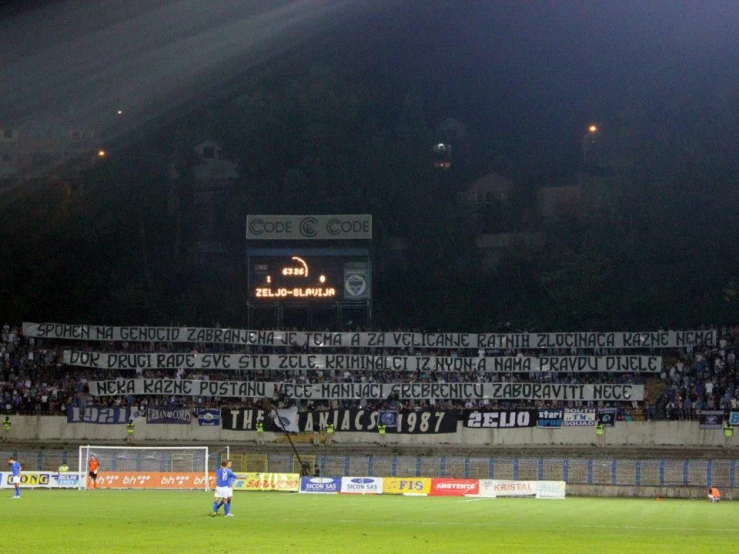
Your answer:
[0,489,739,554]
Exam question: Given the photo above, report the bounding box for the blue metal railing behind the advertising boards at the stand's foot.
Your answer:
[0,448,739,488]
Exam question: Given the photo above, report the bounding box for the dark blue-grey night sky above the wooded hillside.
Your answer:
[0,0,739,161]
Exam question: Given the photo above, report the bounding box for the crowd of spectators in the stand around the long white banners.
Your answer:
[0,324,739,420]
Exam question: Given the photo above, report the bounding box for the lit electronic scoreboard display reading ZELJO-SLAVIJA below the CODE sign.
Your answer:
[248,250,371,304]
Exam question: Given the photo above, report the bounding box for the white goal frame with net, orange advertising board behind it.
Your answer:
[78,445,210,491]
